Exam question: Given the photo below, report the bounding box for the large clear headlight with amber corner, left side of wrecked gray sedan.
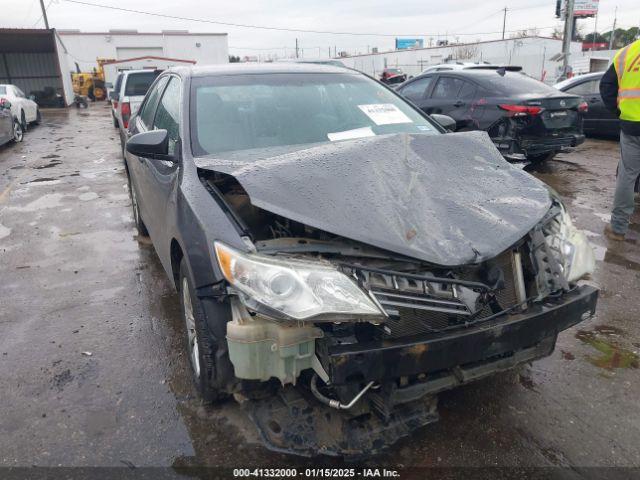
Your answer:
[215,242,383,321]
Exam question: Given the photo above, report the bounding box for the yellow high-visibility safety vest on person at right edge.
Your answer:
[613,40,640,122]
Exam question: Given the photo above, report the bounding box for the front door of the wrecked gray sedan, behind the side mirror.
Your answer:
[140,75,182,246]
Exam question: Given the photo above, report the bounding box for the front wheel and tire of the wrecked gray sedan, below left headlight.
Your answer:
[178,258,226,403]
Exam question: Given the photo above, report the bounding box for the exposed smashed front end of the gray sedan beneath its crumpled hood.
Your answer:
[199,170,595,454]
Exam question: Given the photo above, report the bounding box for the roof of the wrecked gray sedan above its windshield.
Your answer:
[169,62,358,77]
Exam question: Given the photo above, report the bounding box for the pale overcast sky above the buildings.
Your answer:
[0,0,640,57]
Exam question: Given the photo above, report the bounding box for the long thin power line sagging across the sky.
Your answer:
[62,0,554,37]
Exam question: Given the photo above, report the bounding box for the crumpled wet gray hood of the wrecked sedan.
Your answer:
[196,132,551,266]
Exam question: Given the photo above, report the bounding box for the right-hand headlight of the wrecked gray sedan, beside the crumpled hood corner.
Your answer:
[545,202,596,283]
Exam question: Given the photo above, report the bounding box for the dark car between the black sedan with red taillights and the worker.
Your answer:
[554,72,620,137]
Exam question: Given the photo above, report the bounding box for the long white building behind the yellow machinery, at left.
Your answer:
[58,30,229,72]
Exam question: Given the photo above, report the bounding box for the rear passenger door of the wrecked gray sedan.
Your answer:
[123,77,169,229]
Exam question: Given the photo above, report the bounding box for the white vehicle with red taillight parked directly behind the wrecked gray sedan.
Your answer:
[109,70,161,156]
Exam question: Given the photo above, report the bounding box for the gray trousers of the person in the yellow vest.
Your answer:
[611,132,640,235]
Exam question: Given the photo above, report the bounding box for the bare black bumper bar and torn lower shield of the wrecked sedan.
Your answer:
[243,286,598,456]
